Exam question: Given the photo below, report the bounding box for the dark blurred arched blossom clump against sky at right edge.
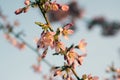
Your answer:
[88,16,120,36]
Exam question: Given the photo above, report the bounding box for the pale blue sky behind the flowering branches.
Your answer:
[0,0,120,80]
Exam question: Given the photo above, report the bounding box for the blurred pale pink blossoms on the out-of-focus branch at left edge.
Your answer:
[0,11,26,50]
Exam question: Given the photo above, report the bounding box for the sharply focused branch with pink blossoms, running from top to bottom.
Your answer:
[12,0,98,80]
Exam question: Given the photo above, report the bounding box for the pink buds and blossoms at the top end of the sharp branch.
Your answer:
[15,0,69,15]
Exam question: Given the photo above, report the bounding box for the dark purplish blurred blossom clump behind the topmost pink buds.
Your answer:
[48,1,84,30]
